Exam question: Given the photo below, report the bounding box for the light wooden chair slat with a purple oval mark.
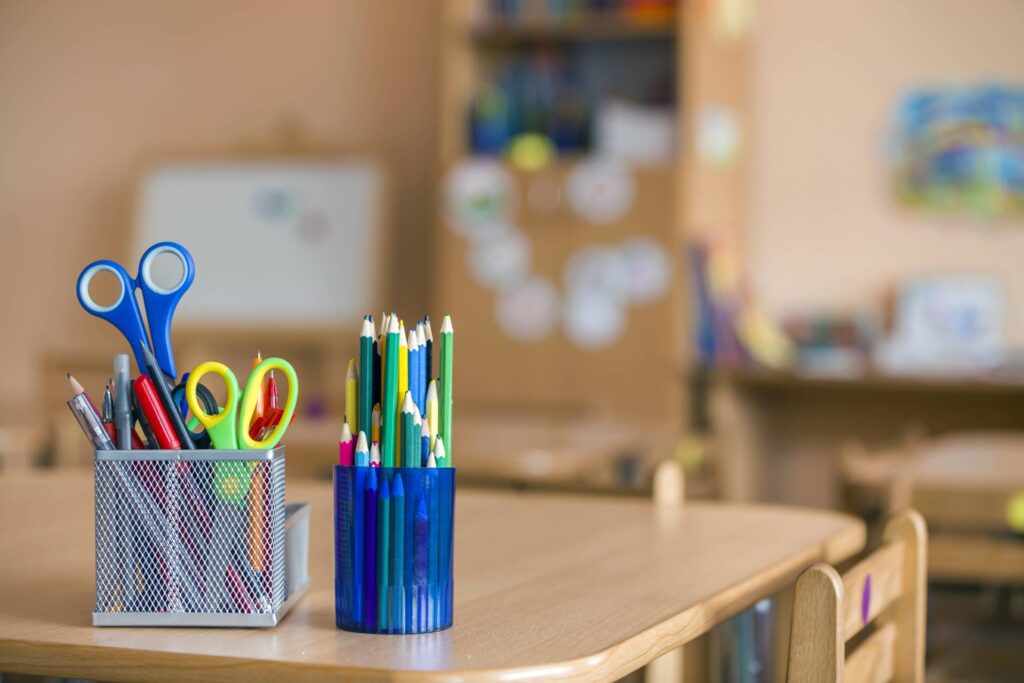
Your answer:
[842,542,904,640]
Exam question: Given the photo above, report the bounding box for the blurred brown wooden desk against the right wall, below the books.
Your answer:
[690,371,1024,507]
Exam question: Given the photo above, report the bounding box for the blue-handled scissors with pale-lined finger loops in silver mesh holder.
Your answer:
[78,242,196,380]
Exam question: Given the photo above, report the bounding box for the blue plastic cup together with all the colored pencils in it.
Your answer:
[336,313,455,633]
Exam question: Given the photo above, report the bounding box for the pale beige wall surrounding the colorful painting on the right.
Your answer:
[748,0,1024,345]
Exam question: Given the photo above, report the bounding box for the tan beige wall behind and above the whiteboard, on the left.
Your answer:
[0,0,438,422]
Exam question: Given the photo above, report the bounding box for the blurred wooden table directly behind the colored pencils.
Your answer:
[286,411,676,494]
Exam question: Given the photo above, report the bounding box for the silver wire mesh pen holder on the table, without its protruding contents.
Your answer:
[92,446,309,627]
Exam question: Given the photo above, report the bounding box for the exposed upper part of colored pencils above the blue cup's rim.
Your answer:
[338,313,455,467]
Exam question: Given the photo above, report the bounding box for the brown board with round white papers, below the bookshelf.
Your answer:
[435,160,682,419]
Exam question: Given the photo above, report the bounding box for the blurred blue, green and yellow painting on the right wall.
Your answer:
[892,85,1024,218]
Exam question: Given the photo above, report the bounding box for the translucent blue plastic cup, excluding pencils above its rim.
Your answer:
[334,465,456,634]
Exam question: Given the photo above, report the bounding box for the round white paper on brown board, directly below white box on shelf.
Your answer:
[566,159,636,225]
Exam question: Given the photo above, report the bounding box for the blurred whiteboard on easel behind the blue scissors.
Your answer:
[129,160,384,327]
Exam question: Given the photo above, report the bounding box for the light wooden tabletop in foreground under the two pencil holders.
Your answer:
[0,471,864,683]
